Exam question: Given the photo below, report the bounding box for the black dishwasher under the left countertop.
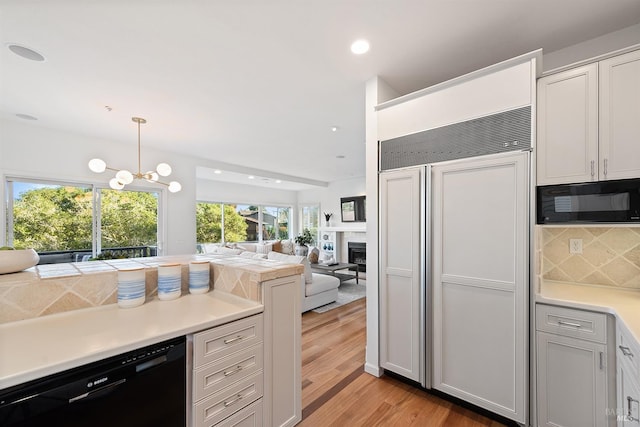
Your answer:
[0,337,187,427]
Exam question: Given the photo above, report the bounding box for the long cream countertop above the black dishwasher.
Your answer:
[0,290,263,390]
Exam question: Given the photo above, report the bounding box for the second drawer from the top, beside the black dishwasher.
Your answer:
[193,344,263,402]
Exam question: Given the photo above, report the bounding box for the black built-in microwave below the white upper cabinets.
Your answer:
[536,179,640,224]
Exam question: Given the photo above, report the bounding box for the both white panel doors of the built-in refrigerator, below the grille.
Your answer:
[379,151,530,423]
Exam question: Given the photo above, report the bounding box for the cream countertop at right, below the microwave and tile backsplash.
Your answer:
[536,281,640,345]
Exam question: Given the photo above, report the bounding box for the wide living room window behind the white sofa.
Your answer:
[196,202,291,244]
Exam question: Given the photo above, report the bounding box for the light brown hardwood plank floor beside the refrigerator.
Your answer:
[298,299,505,427]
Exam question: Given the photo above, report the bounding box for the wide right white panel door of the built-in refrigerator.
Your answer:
[431,152,529,424]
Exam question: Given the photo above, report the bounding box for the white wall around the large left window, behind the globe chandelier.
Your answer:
[0,119,196,254]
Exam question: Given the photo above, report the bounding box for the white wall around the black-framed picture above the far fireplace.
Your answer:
[298,177,362,227]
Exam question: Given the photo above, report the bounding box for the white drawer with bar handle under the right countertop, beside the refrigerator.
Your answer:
[536,304,607,344]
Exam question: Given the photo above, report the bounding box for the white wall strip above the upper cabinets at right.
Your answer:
[542,24,640,71]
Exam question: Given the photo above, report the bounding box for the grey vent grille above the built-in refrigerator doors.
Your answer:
[380,106,531,170]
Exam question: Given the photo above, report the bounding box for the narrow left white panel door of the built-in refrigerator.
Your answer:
[380,168,424,381]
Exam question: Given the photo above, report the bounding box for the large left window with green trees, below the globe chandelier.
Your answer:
[6,179,161,264]
